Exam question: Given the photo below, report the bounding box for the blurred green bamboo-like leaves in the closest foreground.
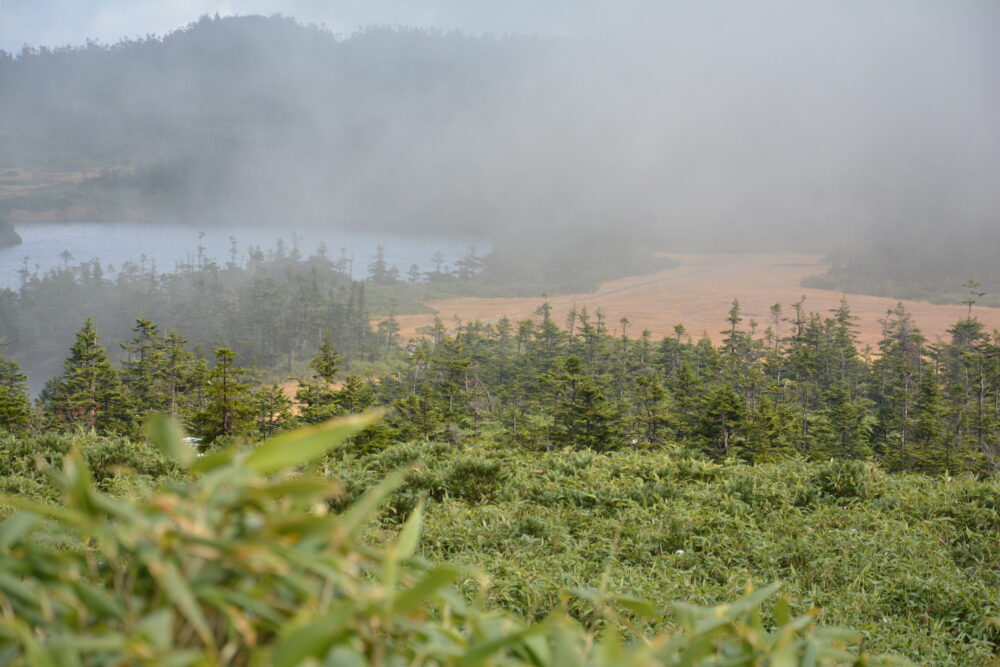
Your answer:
[0,418,898,666]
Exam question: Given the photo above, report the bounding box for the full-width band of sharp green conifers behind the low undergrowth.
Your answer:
[0,294,1000,472]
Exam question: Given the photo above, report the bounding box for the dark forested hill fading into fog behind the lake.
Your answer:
[0,16,549,233]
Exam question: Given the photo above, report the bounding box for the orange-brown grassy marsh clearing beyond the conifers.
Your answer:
[397,253,1000,345]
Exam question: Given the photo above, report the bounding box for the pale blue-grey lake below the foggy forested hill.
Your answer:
[0,222,487,289]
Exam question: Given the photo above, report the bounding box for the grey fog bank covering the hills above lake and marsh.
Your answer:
[0,0,1000,250]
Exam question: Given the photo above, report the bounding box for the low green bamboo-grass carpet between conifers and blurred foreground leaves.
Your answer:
[330,443,1000,665]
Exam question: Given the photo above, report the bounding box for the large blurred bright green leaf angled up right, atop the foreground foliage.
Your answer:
[243,412,381,475]
